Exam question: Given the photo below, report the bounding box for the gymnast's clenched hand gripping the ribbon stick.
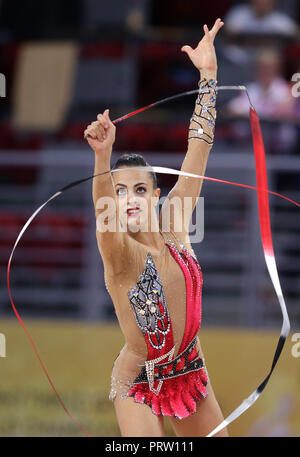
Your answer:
[84,109,116,153]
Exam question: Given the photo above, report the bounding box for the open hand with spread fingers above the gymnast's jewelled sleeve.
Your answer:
[181,18,224,71]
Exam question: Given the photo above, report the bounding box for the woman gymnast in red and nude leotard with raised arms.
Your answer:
[84,19,228,437]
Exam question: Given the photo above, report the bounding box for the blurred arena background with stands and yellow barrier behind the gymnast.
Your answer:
[0,0,300,436]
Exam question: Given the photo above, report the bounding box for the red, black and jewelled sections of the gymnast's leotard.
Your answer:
[110,230,209,419]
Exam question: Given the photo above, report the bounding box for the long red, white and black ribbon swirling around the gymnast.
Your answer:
[7,86,300,437]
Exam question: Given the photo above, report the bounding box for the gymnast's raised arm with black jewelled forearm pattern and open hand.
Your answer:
[161,19,224,232]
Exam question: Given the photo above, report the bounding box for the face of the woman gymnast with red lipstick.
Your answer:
[112,167,160,233]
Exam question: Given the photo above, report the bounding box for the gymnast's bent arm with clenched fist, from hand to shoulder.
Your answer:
[84,109,124,261]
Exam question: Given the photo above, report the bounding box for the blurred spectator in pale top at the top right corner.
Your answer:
[224,0,298,37]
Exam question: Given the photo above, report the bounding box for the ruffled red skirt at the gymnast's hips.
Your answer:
[127,367,208,419]
